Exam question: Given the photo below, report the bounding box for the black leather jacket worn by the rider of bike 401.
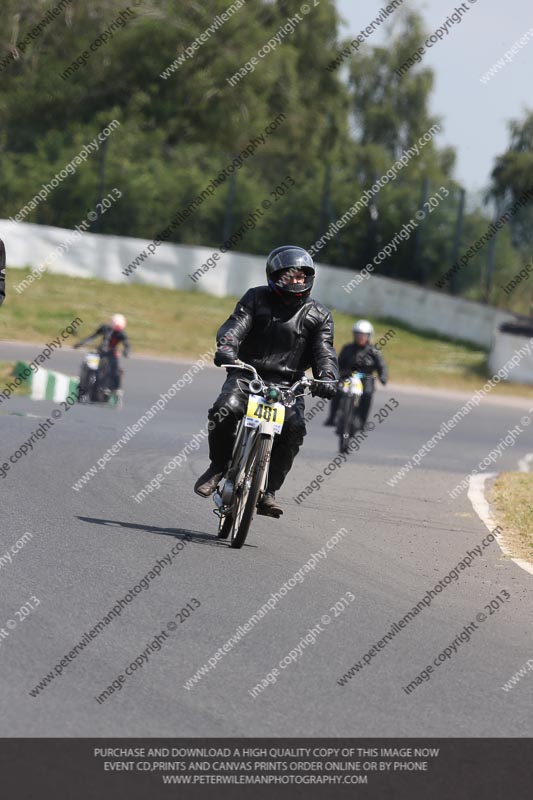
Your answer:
[217,286,339,383]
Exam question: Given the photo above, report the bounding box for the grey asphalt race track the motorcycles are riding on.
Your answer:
[0,344,533,737]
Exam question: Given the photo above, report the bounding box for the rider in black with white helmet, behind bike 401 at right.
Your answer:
[324,319,387,430]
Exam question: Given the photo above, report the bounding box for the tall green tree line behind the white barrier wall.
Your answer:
[0,0,533,312]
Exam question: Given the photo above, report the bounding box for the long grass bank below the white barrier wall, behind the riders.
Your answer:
[0,269,533,398]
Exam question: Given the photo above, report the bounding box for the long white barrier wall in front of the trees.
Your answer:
[0,220,514,348]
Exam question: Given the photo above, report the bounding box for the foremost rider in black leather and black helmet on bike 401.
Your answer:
[194,245,338,517]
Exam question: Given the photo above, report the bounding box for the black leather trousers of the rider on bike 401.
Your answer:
[208,370,306,492]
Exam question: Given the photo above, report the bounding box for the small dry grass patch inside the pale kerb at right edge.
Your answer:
[489,472,533,564]
